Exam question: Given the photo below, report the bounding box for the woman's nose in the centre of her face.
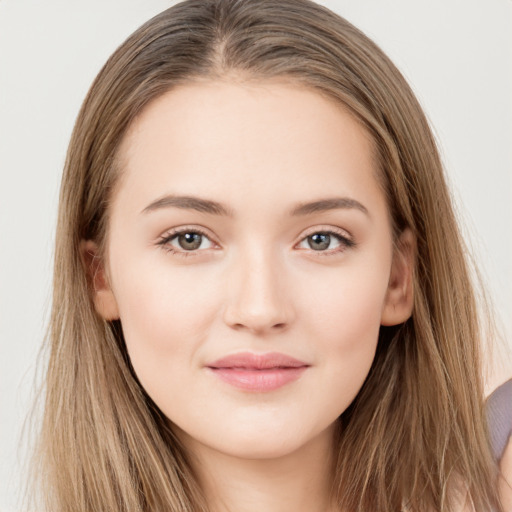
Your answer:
[224,251,294,336]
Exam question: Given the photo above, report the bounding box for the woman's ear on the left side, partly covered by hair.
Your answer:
[80,240,119,321]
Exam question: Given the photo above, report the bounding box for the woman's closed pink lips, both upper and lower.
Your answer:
[207,352,309,392]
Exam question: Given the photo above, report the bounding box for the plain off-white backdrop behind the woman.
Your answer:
[0,0,512,512]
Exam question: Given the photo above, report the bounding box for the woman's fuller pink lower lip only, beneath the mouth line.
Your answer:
[210,366,308,392]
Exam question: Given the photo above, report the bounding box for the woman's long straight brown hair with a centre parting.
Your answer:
[31,0,499,512]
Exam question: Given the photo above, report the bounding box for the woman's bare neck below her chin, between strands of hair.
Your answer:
[180,424,335,512]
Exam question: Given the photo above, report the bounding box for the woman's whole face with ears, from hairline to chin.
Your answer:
[88,81,411,458]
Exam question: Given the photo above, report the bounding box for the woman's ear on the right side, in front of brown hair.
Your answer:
[381,228,416,326]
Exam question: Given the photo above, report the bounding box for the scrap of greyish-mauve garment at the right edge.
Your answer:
[487,379,512,461]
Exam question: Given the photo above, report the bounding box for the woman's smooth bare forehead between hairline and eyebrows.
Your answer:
[114,81,382,218]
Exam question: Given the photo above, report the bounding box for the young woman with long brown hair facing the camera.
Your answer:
[33,0,508,512]
